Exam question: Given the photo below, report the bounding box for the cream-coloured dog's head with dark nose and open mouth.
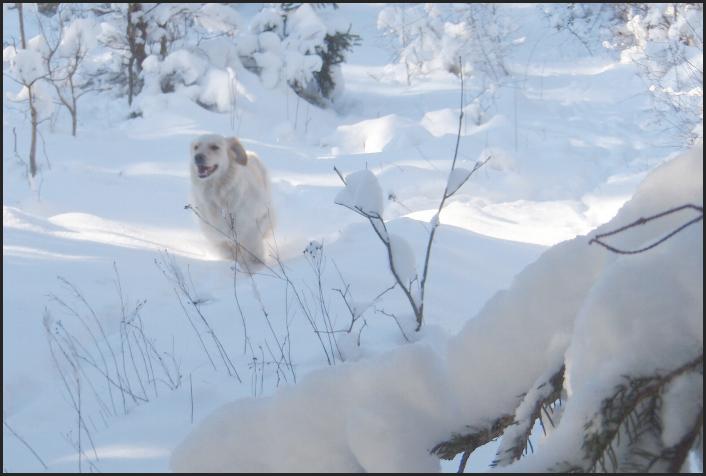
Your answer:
[191,134,248,179]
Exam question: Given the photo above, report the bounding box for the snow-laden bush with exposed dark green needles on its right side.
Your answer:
[136,4,358,111]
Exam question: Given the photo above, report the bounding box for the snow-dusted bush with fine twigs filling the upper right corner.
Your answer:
[541,3,703,143]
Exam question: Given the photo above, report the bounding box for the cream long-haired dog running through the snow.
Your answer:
[191,134,274,270]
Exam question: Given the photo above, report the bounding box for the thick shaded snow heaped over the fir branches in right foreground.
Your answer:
[171,147,703,472]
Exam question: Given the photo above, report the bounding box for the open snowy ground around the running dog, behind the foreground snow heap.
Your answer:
[3,4,703,472]
